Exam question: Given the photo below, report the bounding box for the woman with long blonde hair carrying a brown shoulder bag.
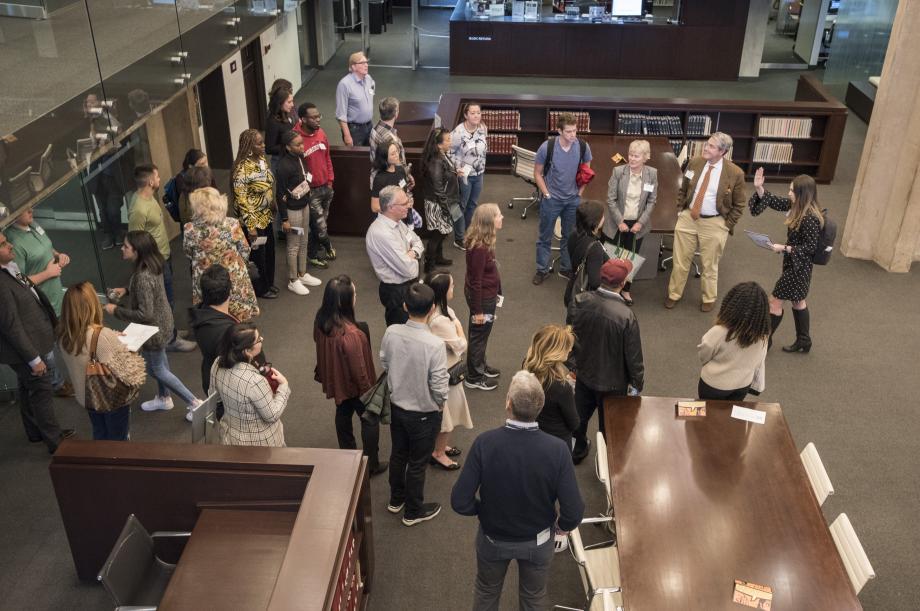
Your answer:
[58,282,145,441]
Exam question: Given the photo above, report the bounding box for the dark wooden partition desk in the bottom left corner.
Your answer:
[50,440,374,611]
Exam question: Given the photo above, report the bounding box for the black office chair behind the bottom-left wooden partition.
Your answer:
[96,513,192,611]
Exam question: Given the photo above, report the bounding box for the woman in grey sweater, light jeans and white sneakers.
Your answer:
[104,231,201,422]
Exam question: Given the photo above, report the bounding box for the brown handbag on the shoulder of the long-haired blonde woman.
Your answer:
[84,327,146,413]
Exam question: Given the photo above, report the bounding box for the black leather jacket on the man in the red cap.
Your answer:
[569,289,645,395]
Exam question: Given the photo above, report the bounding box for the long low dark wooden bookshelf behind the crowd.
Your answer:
[438,74,847,184]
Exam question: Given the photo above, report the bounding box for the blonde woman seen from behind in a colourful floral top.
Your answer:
[183,187,259,322]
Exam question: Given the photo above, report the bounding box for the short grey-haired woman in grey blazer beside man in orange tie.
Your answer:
[604,140,658,306]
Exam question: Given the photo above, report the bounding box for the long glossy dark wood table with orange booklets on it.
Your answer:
[604,397,862,611]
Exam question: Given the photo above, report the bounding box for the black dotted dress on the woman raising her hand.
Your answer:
[748,191,821,301]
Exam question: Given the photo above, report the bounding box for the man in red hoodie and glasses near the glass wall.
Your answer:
[294,102,335,269]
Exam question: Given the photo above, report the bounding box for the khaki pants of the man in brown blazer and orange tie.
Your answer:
[668,210,728,303]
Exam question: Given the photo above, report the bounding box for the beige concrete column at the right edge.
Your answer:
[841,2,920,272]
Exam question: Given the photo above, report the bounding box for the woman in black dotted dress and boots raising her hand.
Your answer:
[748,168,824,352]
